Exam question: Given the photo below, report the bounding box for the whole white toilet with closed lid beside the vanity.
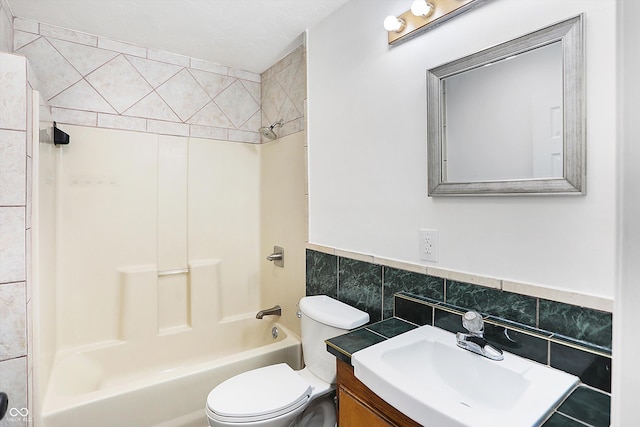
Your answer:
[206,295,369,427]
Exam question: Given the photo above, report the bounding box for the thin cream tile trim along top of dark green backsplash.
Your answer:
[306,243,613,313]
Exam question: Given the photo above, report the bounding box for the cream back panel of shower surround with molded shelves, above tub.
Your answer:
[56,126,260,350]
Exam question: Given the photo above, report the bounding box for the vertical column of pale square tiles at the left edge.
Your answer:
[0,51,31,426]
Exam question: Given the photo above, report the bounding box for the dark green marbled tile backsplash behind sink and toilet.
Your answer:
[306,249,612,392]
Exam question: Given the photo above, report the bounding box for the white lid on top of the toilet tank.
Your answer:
[300,295,369,330]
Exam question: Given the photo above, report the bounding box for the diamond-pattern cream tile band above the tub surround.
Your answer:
[13,18,306,143]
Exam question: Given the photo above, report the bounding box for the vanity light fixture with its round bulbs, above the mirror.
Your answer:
[384,0,484,44]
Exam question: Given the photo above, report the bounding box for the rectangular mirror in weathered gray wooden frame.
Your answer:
[427,15,586,196]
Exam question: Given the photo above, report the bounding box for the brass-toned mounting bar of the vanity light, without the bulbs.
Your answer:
[388,0,484,44]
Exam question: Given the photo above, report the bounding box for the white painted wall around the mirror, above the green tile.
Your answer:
[308,0,616,298]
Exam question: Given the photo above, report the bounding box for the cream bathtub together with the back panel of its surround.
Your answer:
[35,125,308,427]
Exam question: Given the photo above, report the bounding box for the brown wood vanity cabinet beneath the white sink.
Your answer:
[337,359,420,427]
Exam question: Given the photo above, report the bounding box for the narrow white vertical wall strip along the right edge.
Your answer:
[611,0,640,426]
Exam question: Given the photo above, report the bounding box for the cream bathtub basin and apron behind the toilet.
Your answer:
[41,316,302,427]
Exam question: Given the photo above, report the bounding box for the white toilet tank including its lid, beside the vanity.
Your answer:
[300,295,369,384]
